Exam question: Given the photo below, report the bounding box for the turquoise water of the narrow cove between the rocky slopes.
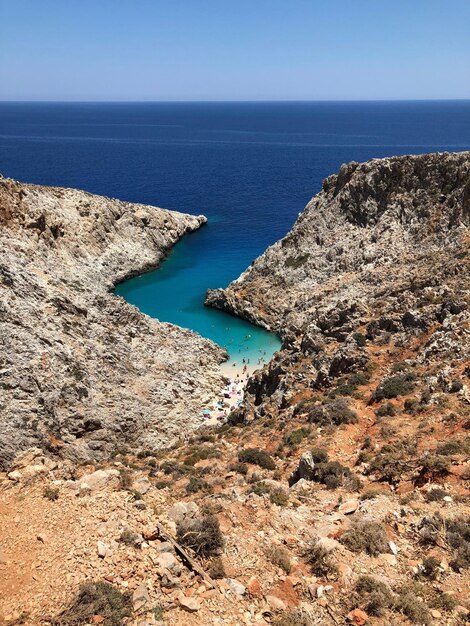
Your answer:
[115,223,281,366]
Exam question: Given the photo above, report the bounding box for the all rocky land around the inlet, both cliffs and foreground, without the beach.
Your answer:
[0,153,470,626]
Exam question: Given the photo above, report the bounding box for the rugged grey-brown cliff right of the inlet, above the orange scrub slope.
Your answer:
[206,152,470,419]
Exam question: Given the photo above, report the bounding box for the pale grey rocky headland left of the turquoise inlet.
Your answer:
[0,178,223,466]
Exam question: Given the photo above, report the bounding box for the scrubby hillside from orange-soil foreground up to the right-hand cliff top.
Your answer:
[0,153,470,626]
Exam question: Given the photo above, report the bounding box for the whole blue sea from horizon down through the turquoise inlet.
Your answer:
[0,101,470,360]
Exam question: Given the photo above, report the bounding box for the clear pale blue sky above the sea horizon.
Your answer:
[0,0,470,100]
